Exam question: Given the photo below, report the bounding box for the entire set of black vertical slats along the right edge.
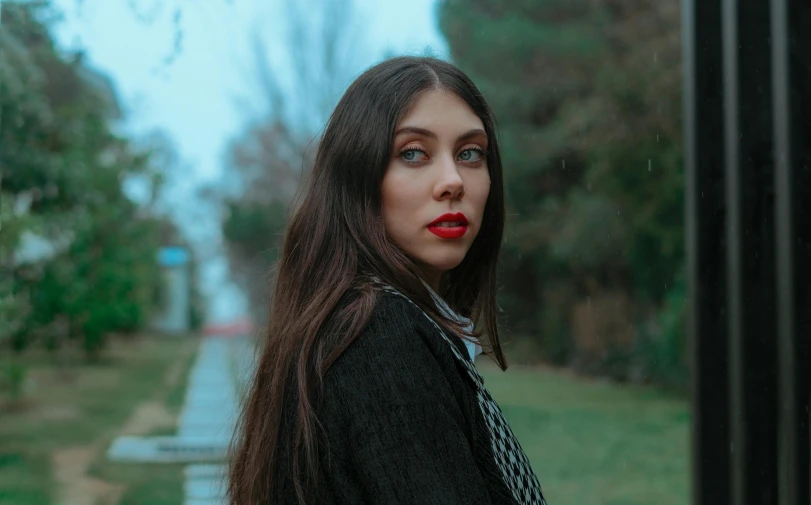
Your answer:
[682,0,811,505]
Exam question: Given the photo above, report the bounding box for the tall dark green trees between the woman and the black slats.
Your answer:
[440,0,684,384]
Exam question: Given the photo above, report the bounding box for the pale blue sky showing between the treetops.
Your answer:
[48,0,447,321]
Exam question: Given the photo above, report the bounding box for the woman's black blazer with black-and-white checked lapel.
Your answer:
[273,288,546,505]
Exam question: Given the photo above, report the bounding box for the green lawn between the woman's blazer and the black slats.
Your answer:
[476,358,690,505]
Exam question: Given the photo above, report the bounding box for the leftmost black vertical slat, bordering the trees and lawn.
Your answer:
[682,0,731,505]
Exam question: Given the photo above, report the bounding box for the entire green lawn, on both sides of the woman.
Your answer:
[0,338,689,505]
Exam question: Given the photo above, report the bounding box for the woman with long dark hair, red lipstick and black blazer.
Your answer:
[229,57,545,505]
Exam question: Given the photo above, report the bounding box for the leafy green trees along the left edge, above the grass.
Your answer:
[0,2,185,356]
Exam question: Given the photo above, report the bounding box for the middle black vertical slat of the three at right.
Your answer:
[723,0,778,505]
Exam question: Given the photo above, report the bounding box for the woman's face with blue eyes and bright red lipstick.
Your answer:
[382,90,490,289]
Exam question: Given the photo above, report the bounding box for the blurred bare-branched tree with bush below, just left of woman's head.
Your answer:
[216,0,365,321]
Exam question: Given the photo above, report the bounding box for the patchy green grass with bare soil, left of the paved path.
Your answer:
[0,338,198,505]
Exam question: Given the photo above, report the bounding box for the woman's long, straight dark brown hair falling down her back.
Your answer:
[228,57,507,505]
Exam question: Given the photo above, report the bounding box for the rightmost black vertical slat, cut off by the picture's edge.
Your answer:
[772,0,811,505]
